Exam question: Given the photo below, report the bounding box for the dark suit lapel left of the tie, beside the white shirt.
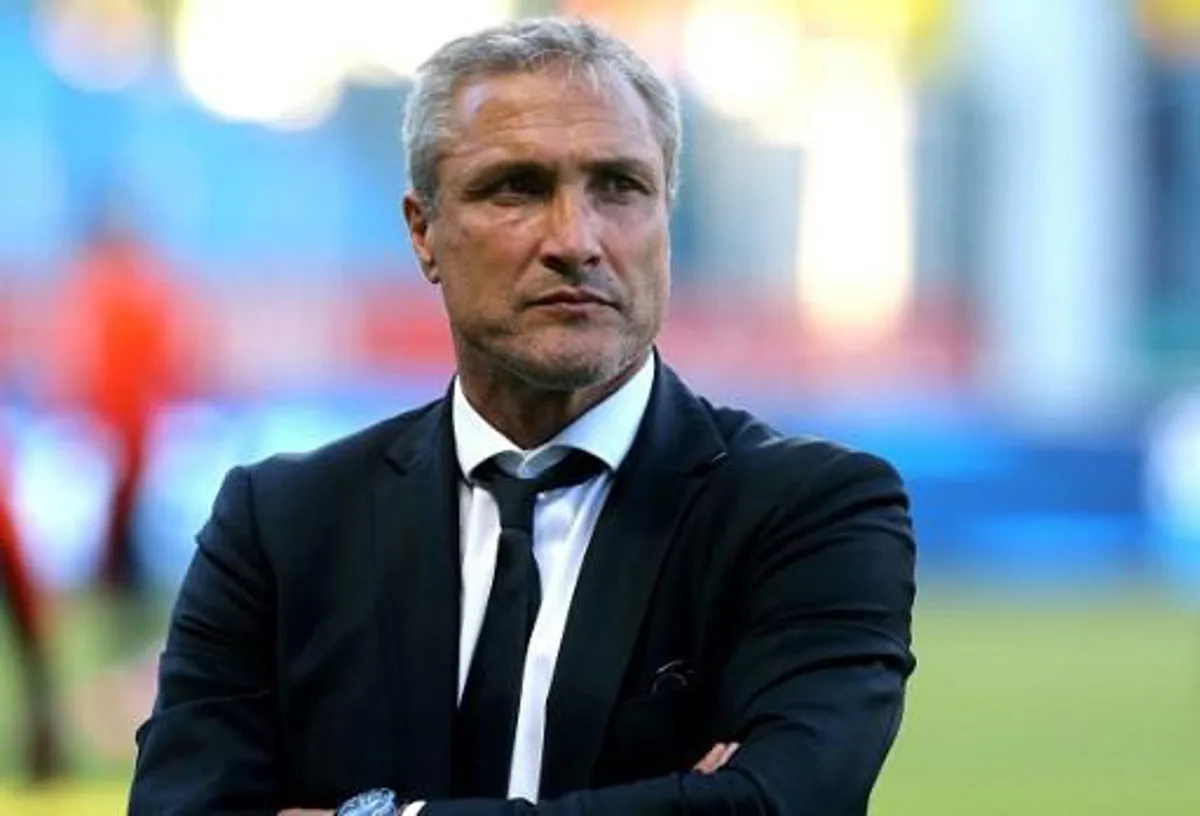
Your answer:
[372,400,462,797]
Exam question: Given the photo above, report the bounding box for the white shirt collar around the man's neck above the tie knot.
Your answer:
[451,354,654,478]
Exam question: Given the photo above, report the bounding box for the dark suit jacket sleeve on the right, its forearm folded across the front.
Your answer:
[421,452,914,816]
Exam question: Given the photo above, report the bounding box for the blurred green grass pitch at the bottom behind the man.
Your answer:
[0,590,1200,816]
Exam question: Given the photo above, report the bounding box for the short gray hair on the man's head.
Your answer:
[403,18,683,210]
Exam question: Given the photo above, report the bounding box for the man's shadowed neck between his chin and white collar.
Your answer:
[458,350,649,450]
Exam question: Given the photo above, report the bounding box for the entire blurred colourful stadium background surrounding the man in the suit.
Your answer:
[0,0,1200,816]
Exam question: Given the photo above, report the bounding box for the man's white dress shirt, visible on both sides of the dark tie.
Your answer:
[404,356,654,816]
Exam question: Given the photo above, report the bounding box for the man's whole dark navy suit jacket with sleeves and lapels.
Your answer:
[130,365,914,816]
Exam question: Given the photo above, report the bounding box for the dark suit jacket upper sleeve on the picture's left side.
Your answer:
[128,468,280,816]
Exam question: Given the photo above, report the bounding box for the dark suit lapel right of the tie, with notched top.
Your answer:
[540,364,724,798]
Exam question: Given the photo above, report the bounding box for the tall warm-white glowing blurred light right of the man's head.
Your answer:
[797,41,913,343]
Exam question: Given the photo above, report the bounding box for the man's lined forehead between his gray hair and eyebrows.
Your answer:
[443,68,664,172]
